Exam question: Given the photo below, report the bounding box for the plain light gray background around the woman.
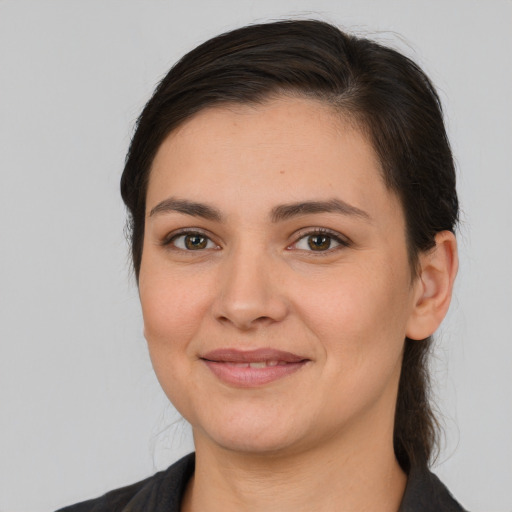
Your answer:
[0,0,512,512]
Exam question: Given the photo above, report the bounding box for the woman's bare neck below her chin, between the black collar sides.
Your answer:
[182,418,407,512]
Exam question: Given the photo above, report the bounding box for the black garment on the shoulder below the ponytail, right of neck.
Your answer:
[399,468,467,512]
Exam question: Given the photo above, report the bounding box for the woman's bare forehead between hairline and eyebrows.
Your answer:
[147,98,396,221]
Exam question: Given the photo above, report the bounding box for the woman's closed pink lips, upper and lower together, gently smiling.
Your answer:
[201,348,309,388]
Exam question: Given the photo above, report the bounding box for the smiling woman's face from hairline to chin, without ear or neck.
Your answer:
[139,99,418,452]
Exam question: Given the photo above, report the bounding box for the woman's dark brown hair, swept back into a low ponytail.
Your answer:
[121,20,458,471]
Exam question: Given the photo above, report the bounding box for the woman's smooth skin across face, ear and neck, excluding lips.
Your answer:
[139,97,457,512]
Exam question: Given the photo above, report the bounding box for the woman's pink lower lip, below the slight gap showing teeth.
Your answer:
[203,359,307,388]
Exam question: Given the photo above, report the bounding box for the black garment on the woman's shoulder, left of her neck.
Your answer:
[57,453,195,512]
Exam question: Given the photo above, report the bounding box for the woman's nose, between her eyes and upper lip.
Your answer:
[212,247,288,331]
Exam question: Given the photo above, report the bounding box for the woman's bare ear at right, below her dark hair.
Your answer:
[406,231,459,340]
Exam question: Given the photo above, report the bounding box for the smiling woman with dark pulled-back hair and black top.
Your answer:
[59,21,463,512]
